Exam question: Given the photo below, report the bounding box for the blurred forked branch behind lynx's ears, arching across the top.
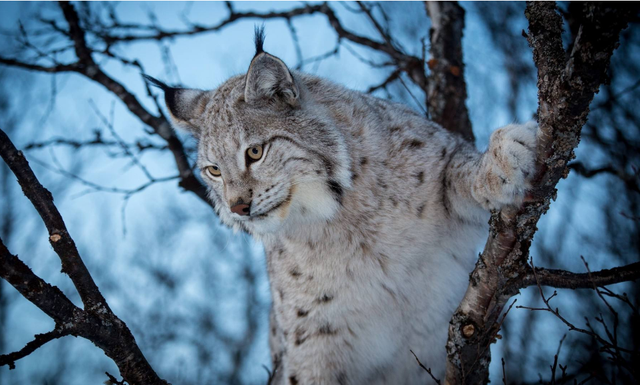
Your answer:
[0,2,438,200]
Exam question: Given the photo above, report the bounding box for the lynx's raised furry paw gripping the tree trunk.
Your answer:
[473,122,538,210]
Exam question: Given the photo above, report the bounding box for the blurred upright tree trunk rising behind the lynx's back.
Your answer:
[425,1,474,142]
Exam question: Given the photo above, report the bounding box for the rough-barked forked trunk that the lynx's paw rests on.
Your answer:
[445,2,631,384]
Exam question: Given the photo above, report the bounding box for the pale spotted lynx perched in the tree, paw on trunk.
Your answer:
[148,31,537,385]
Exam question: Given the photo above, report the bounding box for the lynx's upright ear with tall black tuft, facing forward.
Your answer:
[244,28,300,107]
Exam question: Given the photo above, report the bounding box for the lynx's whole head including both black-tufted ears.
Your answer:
[147,28,351,235]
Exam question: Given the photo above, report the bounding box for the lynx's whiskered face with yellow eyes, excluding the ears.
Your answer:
[198,92,344,234]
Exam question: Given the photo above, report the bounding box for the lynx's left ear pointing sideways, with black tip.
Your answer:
[142,75,207,136]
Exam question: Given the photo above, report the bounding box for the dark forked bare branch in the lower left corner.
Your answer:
[0,130,167,385]
